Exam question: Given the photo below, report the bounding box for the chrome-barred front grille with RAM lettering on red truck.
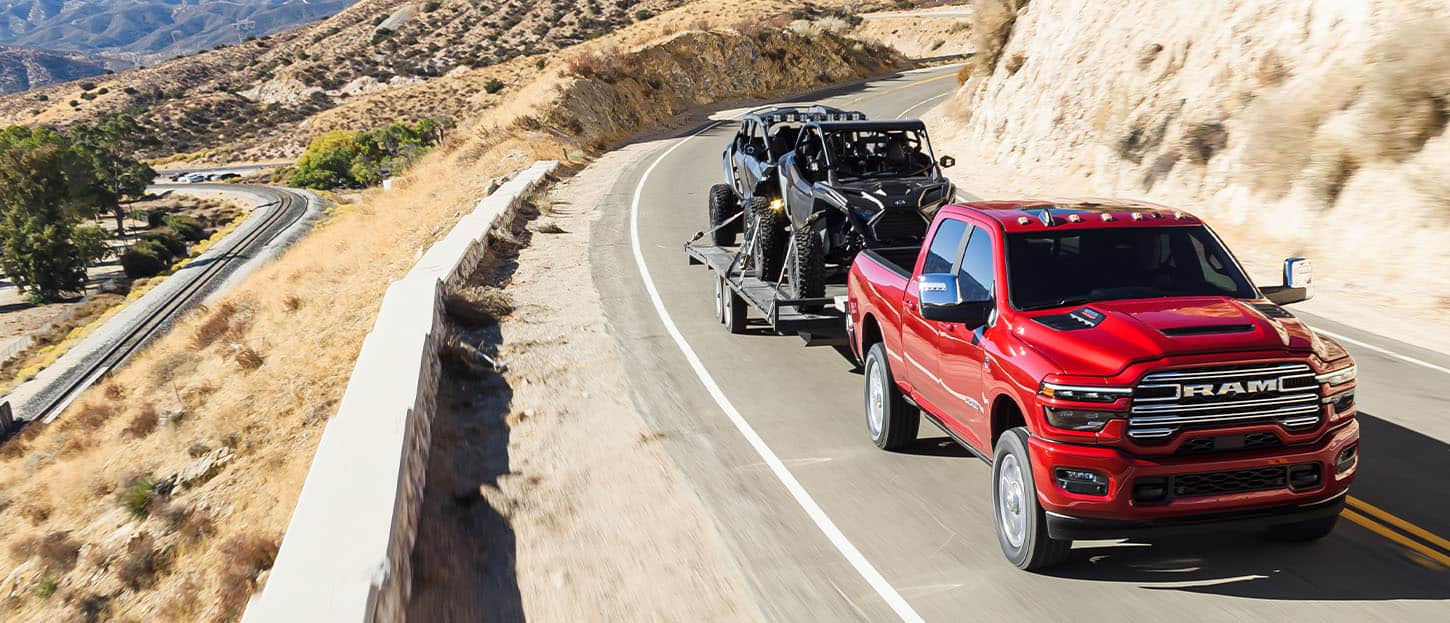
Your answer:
[1128,364,1322,446]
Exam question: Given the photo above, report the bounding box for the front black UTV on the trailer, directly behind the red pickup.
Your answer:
[773,120,956,298]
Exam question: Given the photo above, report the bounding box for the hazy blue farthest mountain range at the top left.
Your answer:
[0,0,355,58]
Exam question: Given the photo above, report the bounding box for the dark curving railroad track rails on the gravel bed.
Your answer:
[23,184,307,423]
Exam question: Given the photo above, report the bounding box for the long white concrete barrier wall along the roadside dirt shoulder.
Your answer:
[244,162,558,623]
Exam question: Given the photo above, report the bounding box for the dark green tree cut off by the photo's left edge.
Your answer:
[0,126,96,303]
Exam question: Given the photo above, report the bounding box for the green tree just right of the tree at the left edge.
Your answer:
[70,114,157,241]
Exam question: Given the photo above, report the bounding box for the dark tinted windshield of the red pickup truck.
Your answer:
[1008,227,1254,310]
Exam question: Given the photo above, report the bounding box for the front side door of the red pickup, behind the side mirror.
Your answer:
[937,227,998,451]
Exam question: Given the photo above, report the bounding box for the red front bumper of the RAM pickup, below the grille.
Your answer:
[1028,420,1359,539]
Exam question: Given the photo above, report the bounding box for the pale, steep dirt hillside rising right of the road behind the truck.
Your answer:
[929,0,1450,350]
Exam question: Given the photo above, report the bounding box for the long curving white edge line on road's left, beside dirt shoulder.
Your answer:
[629,122,922,623]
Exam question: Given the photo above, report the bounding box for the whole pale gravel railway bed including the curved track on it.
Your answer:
[0,184,318,422]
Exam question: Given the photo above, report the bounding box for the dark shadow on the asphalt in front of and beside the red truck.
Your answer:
[1051,413,1450,601]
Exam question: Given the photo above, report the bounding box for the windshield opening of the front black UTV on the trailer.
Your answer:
[825,129,935,180]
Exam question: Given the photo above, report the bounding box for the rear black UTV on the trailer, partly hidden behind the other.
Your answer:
[708,106,866,277]
